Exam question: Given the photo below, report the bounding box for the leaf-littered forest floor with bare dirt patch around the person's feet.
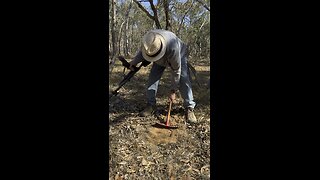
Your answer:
[109,59,211,180]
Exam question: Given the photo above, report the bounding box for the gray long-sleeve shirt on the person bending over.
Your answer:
[133,29,187,90]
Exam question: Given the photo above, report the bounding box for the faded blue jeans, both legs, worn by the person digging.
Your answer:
[147,57,196,108]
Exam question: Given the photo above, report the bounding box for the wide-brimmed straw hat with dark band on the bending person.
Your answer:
[141,32,166,62]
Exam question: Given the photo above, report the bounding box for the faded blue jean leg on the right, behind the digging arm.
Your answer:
[180,49,196,108]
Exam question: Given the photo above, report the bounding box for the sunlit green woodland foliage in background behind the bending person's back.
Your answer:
[109,0,210,59]
